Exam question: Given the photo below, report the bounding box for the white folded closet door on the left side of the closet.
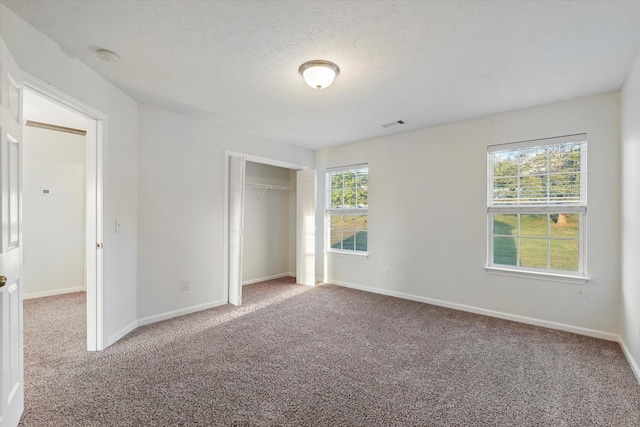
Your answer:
[229,156,245,305]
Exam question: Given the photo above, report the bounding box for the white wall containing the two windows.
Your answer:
[316,93,620,340]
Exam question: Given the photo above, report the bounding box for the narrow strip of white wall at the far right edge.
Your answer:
[620,51,640,381]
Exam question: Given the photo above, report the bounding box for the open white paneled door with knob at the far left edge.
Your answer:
[0,38,24,427]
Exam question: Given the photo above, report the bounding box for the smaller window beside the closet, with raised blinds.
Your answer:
[325,165,369,254]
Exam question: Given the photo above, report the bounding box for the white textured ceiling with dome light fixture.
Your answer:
[1,0,640,149]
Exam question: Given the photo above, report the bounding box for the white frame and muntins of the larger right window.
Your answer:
[485,134,589,284]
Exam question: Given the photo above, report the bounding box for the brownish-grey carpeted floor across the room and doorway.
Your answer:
[21,279,640,427]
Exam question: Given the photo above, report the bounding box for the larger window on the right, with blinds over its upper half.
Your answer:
[487,134,587,277]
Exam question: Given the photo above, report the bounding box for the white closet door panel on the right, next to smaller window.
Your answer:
[296,169,316,286]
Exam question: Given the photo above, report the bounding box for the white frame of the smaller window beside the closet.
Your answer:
[324,163,369,258]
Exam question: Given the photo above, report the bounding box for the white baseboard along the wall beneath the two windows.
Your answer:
[328,280,619,342]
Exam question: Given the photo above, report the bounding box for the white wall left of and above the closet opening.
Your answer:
[138,105,314,324]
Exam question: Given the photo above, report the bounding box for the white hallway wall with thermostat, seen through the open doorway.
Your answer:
[22,126,86,298]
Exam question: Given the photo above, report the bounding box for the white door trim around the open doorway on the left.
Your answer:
[23,72,108,351]
